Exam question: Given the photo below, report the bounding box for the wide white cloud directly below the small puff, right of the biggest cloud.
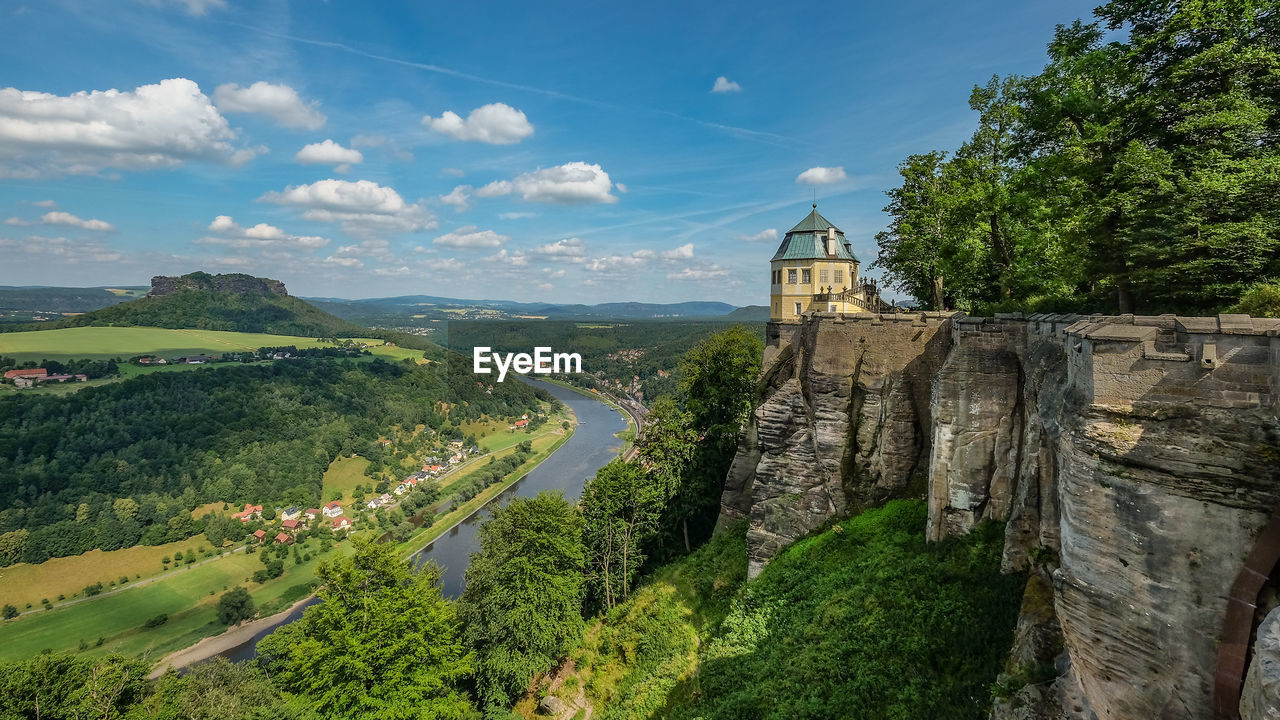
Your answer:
[259,178,436,237]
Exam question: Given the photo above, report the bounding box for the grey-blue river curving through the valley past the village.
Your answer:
[218,378,627,661]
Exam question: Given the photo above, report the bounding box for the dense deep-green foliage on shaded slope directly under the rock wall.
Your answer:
[675,501,1024,720]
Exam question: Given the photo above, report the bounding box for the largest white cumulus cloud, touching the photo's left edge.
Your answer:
[0,78,252,178]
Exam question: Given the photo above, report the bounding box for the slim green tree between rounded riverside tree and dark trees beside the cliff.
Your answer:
[581,460,663,609]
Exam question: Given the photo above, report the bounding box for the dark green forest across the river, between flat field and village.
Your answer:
[0,360,545,565]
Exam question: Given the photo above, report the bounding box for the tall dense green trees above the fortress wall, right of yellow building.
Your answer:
[877,0,1280,313]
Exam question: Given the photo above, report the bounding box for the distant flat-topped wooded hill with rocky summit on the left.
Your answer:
[5,272,369,337]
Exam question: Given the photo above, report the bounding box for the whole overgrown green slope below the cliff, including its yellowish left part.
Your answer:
[535,501,1024,720]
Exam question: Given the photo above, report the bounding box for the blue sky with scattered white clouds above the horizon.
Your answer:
[0,0,1097,305]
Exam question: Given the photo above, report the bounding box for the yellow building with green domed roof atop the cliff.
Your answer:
[769,202,867,320]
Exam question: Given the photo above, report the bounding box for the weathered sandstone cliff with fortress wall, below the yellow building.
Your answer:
[723,310,1280,720]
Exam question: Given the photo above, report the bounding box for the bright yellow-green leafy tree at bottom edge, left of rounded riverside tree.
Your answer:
[257,539,474,720]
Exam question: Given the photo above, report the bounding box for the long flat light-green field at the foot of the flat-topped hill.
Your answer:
[0,327,386,363]
